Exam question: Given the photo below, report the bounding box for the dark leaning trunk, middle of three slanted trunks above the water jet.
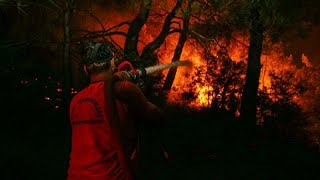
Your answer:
[141,0,181,60]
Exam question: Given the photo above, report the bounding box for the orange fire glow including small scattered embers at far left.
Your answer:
[74,0,320,148]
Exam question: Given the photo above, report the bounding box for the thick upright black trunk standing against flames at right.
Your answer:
[240,8,263,128]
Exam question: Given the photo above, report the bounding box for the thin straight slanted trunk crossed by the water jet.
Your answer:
[161,1,192,94]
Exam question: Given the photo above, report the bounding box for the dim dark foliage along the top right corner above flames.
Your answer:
[196,0,320,41]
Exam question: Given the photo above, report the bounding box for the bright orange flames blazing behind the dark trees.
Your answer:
[79,3,320,136]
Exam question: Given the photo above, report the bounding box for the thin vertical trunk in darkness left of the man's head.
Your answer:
[63,0,75,103]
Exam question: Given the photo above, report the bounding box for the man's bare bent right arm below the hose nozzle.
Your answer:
[114,81,163,122]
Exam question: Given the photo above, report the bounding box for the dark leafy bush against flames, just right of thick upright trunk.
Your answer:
[258,71,307,136]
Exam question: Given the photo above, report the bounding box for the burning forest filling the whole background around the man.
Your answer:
[0,0,320,179]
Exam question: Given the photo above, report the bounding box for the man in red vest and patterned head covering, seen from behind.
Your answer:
[67,41,162,180]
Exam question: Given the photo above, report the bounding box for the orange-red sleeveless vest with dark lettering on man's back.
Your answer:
[67,81,135,180]
